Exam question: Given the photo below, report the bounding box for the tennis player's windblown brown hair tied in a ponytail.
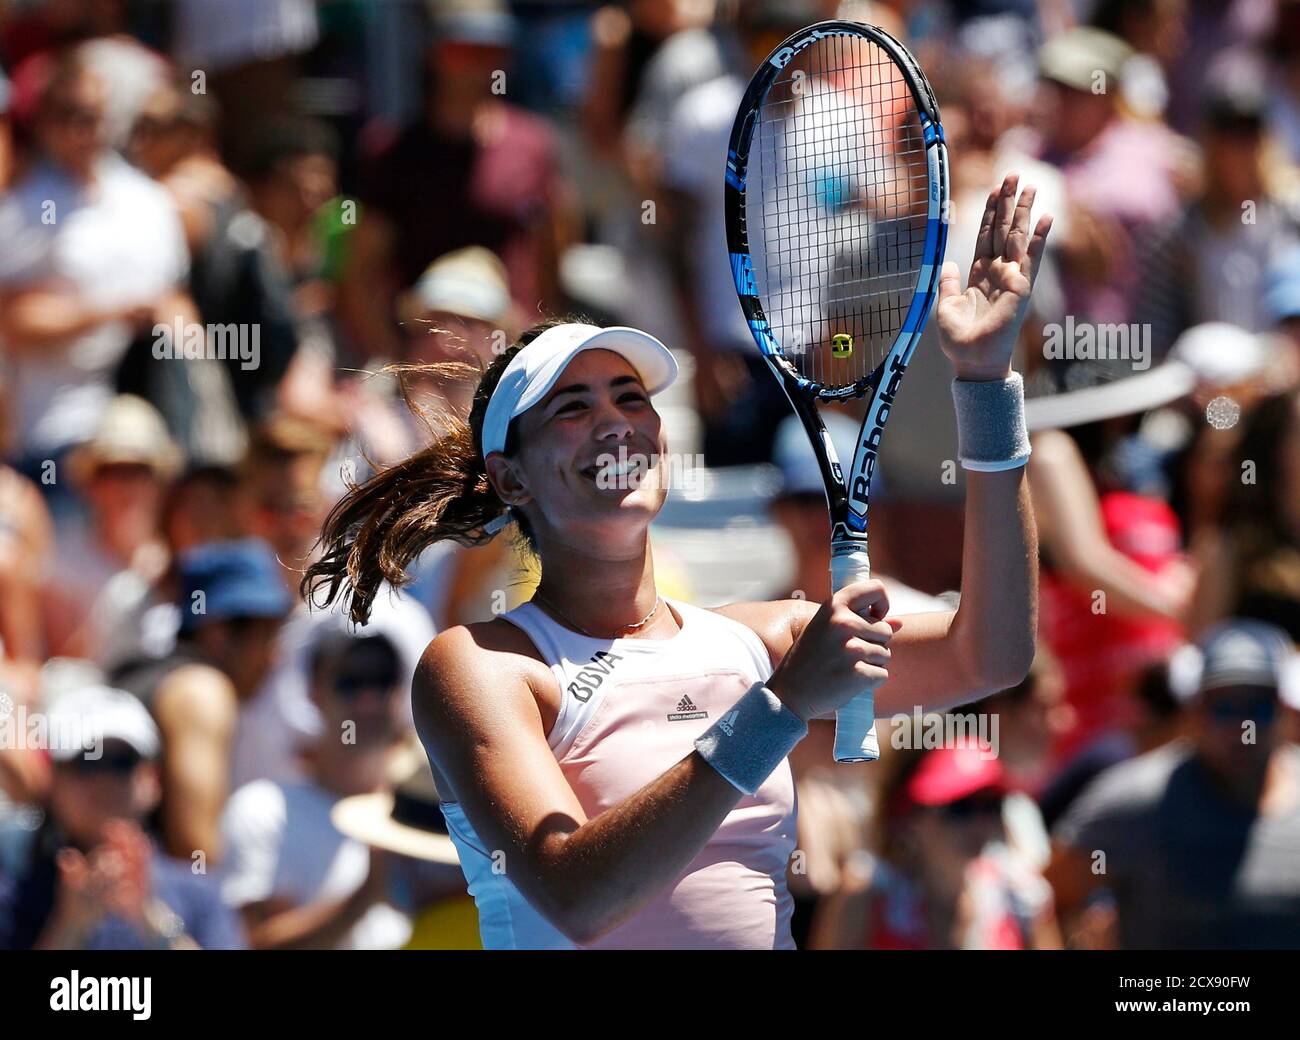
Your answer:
[299,317,585,624]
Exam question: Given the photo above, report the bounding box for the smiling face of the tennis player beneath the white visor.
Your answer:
[488,350,667,558]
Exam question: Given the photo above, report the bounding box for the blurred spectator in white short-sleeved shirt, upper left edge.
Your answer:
[0,49,195,483]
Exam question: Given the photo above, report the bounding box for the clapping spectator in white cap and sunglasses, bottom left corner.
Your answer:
[0,686,243,949]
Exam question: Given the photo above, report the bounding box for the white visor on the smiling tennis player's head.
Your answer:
[482,322,677,459]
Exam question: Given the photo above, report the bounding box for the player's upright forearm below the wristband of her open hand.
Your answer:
[949,467,1039,696]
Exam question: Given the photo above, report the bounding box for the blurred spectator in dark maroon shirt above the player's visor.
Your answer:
[341,0,568,358]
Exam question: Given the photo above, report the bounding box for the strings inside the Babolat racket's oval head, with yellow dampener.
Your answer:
[746,36,930,389]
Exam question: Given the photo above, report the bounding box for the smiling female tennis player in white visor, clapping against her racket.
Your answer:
[304,176,1050,949]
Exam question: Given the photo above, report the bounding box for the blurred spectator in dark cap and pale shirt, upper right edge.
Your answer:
[1136,65,1300,358]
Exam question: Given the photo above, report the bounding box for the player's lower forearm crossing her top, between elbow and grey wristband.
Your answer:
[517,751,741,943]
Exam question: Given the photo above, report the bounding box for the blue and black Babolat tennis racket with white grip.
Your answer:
[725,21,948,762]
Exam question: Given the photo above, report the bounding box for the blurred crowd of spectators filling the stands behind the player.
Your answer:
[0,0,1300,949]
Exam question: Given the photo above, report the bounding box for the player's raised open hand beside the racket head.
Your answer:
[937,173,1052,380]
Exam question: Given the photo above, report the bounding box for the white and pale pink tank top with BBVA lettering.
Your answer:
[443,599,796,949]
